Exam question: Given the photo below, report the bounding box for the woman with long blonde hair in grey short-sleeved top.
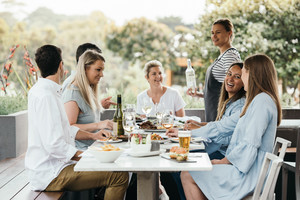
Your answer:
[63,50,112,150]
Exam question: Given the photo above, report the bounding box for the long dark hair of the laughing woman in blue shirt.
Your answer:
[216,62,246,121]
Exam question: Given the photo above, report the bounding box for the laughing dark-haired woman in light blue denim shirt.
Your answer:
[167,63,245,159]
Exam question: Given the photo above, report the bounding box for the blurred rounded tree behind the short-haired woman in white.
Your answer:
[106,18,175,68]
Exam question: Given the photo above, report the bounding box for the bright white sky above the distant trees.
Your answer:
[0,0,205,25]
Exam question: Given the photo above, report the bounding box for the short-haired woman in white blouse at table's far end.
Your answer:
[137,60,186,117]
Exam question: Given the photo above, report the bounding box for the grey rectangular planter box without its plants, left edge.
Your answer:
[0,111,28,160]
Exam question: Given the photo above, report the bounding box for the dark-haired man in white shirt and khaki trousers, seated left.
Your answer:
[25,45,128,199]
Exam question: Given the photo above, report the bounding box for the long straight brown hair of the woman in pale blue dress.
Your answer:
[240,54,282,126]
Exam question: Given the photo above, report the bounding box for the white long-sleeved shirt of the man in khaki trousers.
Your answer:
[25,78,79,190]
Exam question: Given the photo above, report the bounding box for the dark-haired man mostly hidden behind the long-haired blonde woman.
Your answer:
[62,43,117,109]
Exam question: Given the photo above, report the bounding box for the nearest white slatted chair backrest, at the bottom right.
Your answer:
[252,153,283,200]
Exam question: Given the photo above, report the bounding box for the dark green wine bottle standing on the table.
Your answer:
[113,94,124,136]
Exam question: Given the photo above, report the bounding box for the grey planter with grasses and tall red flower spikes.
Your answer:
[0,45,37,160]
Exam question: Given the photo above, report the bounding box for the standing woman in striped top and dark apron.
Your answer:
[187,19,241,122]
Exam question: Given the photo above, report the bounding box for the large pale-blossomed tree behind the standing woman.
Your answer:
[188,0,300,92]
